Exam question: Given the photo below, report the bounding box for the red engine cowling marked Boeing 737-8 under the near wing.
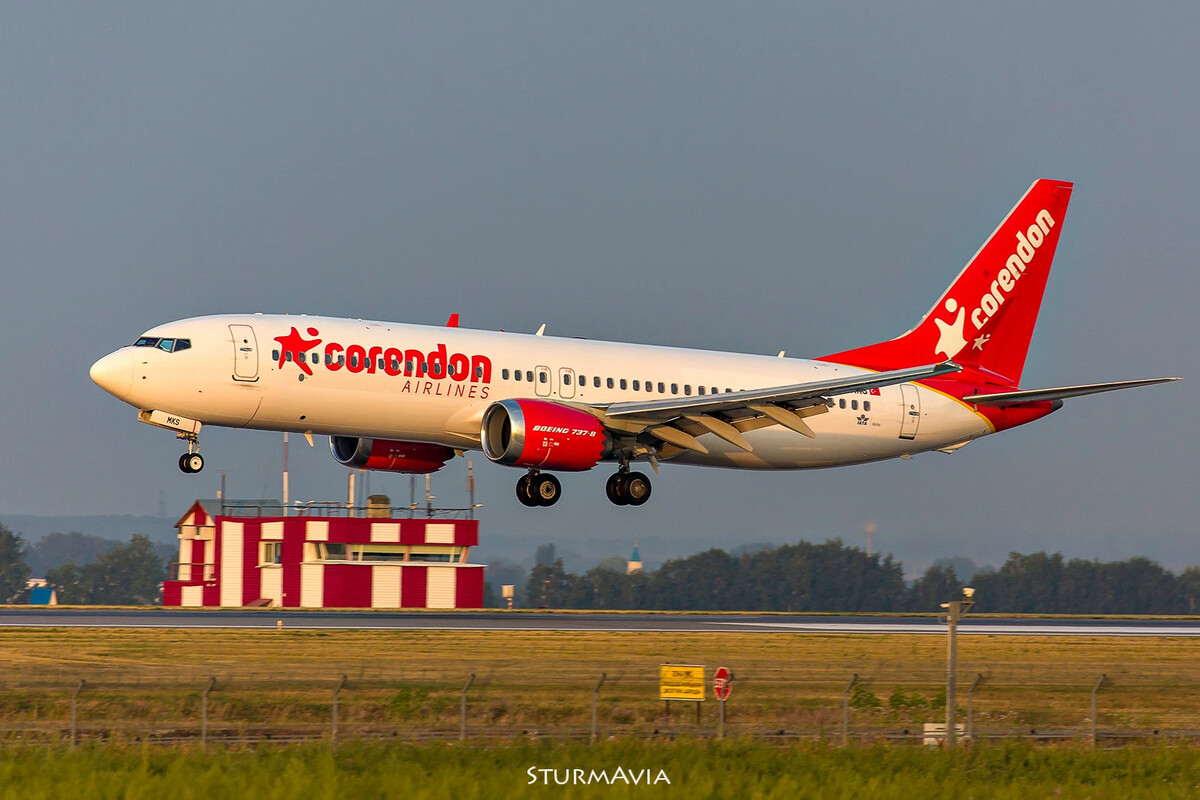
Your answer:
[480,399,612,473]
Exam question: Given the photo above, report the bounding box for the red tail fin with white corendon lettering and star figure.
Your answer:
[822,180,1073,386]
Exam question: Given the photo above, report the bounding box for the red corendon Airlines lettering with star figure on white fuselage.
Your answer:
[275,327,492,399]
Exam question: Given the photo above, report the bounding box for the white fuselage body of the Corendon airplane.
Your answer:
[94,314,992,469]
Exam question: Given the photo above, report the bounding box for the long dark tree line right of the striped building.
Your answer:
[499,540,1200,614]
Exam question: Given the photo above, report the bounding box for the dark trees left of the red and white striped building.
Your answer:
[0,523,167,606]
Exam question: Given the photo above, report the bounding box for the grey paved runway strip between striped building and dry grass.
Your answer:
[0,608,1200,637]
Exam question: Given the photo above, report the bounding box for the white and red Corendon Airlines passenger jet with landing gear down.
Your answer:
[90,180,1178,507]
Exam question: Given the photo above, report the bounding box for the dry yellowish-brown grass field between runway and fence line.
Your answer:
[0,628,1200,738]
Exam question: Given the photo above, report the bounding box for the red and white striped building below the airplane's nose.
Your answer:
[163,500,484,608]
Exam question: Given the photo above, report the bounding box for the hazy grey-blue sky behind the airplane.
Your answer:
[0,2,1200,569]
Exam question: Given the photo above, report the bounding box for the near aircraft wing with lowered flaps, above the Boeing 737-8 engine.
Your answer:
[586,361,962,453]
